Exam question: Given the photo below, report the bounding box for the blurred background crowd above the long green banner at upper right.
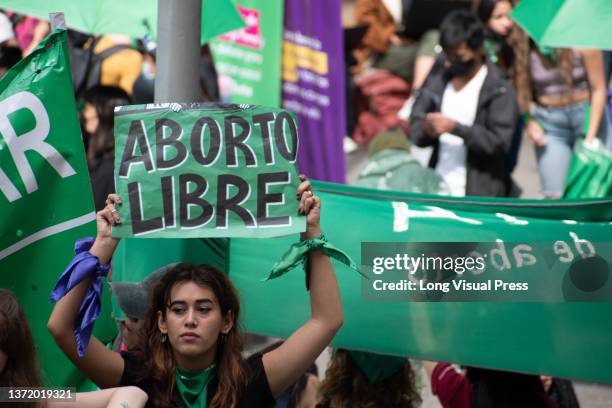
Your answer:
[347,0,612,198]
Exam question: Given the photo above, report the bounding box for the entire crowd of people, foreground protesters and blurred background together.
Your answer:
[0,0,612,408]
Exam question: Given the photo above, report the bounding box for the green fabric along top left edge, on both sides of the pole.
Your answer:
[0,0,244,44]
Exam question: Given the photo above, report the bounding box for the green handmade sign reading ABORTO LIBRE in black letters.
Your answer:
[113,103,306,238]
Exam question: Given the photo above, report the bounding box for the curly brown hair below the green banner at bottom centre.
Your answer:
[317,349,421,408]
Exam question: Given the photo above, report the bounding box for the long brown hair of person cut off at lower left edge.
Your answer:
[0,289,42,408]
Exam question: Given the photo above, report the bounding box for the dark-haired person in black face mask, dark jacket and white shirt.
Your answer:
[409,10,519,197]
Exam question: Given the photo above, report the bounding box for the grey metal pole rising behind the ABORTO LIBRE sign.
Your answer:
[155,0,202,102]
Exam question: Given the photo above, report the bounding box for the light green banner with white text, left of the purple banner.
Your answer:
[210,0,284,107]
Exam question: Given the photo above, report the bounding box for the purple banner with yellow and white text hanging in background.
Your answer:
[282,0,346,183]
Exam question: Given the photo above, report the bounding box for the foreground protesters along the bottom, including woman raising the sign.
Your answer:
[0,189,578,408]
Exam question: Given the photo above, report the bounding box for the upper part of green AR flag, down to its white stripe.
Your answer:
[0,31,95,260]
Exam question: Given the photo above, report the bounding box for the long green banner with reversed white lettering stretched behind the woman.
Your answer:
[116,183,612,383]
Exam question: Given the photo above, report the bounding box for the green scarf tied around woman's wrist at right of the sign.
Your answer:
[265,233,367,288]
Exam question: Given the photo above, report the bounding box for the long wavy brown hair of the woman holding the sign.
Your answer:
[137,263,248,408]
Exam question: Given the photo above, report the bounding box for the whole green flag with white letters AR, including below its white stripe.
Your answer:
[0,31,113,385]
